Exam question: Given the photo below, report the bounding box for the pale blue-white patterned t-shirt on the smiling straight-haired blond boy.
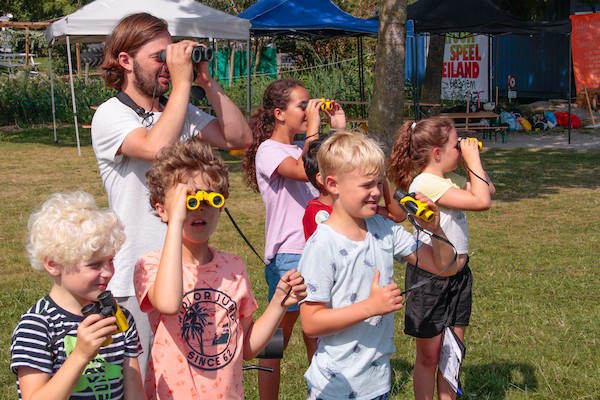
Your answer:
[298,215,418,400]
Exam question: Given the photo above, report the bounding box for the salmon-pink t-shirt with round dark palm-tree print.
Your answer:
[134,249,257,400]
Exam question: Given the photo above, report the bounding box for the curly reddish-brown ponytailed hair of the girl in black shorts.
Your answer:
[388,117,454,191]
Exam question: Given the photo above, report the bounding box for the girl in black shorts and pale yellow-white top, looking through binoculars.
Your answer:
[389,118,495,400]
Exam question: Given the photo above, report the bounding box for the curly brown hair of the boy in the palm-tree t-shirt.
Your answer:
[146,137,229,208]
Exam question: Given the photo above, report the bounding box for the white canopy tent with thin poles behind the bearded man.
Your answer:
[45,0,251,155]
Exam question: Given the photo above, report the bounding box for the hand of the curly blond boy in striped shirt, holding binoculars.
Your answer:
[73,314,117,362]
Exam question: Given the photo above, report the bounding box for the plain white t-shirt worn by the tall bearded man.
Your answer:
[92,97,214,297]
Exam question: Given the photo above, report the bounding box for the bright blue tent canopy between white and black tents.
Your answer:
[238,0,379,37]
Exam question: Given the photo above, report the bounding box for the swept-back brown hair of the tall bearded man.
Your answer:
[101,13,168,90]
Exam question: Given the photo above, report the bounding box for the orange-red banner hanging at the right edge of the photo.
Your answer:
[571,13,600,93]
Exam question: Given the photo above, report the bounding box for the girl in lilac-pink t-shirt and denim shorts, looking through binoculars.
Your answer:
[243,79,346,400]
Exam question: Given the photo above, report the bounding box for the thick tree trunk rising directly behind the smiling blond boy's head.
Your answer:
[369,0,406,154]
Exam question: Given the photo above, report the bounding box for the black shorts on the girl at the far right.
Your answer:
[404,260,473,338]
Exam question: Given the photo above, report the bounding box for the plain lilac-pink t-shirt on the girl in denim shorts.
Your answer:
[256,139,319,263]
